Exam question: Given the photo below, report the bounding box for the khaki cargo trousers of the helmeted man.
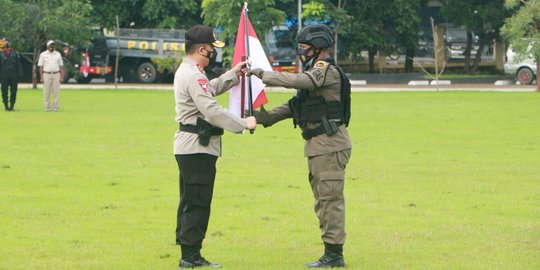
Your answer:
[308,149,351,245]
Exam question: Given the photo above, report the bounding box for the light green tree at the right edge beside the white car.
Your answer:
[501,0,540,91]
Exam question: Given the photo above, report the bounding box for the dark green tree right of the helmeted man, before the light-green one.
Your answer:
[441,0,508,74]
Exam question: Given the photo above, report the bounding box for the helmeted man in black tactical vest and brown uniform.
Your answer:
[247,24,352,268]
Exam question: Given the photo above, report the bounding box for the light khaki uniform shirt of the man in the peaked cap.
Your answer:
[174,58,246,156]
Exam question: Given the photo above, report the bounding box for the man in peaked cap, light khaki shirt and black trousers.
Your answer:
[174,25,256,268]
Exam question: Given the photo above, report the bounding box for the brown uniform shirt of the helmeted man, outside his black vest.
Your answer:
[262,60,352,157]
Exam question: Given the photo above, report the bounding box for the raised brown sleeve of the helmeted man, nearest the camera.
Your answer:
[262,61,329,90]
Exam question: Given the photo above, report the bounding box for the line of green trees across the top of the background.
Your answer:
[0,0,540,79]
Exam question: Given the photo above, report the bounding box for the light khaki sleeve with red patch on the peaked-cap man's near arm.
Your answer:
[188,74,246,133]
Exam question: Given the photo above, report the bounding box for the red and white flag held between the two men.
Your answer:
[229,5,272,118]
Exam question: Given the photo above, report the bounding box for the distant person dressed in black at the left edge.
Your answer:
[0,38,22,111]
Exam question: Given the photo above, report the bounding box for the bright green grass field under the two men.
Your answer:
[0,89,540,270]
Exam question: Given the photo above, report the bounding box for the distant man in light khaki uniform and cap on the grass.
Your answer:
[38,40,64,112]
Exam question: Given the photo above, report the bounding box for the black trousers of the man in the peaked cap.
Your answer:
[175,154,218,249]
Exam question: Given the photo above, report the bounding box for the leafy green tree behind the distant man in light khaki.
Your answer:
[4,0,92,88]
